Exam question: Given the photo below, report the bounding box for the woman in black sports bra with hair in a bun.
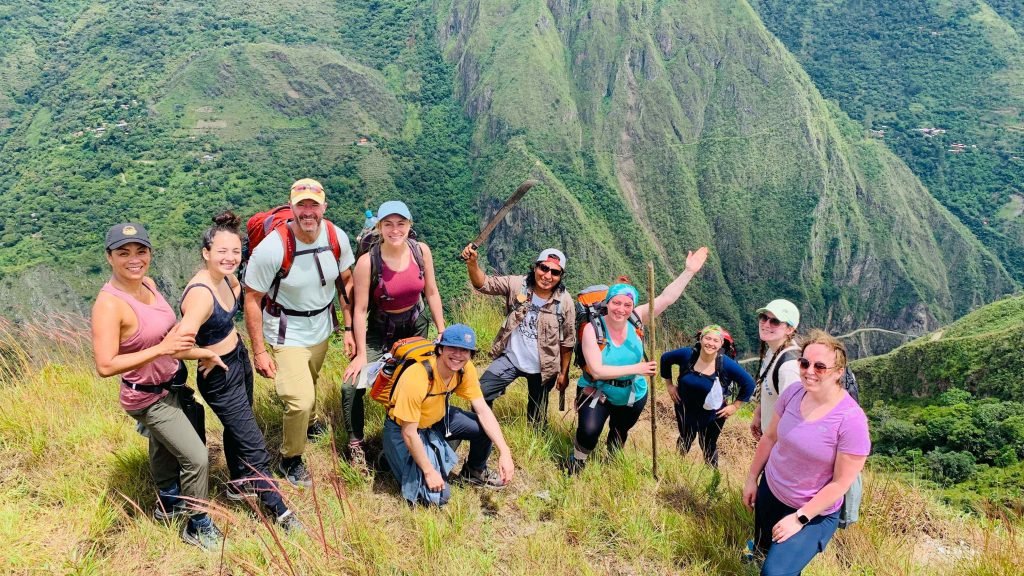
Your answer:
[181,211,301,530]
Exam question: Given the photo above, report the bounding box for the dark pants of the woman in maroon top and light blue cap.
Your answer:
[341,303,430,442]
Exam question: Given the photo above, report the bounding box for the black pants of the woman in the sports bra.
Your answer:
[196,339,288,516]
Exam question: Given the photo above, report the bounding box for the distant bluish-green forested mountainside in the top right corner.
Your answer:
[752,0,1024,281]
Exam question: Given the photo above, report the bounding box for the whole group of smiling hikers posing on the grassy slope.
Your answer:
[92,178,870,574]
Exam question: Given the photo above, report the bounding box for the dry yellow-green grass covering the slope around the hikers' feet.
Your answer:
[0,309,1024,575]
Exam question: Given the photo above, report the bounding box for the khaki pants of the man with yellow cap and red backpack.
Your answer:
[272,340,328,458]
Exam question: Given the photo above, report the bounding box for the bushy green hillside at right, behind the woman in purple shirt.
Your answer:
[854,296,1024,513]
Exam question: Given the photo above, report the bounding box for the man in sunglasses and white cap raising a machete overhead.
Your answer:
[461,180,575,425]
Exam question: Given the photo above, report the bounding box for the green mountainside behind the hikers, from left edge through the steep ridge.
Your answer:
[0,0,1016,347]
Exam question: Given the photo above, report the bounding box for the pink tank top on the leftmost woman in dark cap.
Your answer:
[100,282,178,410]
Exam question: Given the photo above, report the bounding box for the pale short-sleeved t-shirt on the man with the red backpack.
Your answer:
[245,220,355,347]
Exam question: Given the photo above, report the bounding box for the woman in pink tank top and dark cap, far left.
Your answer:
[92,219,221,548]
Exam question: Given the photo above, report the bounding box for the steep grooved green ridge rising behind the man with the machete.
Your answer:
[438,0,1013,347]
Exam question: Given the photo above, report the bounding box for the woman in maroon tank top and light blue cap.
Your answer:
[341,200,444,468]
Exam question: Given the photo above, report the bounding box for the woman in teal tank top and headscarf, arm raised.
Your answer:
[568,247,708,474]
